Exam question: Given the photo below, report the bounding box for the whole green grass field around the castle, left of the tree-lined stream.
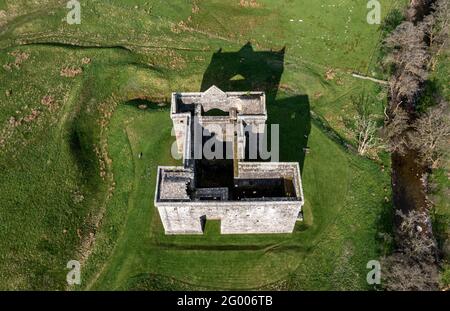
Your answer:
[0,0,414,290]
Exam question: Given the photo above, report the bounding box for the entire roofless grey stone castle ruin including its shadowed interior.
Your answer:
[155,86,304,234]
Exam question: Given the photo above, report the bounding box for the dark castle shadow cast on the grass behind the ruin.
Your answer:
[201,42,311,171]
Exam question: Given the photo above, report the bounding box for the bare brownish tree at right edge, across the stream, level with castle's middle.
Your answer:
[408,102,450,168]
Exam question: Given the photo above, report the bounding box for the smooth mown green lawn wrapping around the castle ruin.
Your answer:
[85,100,387,289]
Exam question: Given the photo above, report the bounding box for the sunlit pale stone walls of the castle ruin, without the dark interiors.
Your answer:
[155,86,304,234]
